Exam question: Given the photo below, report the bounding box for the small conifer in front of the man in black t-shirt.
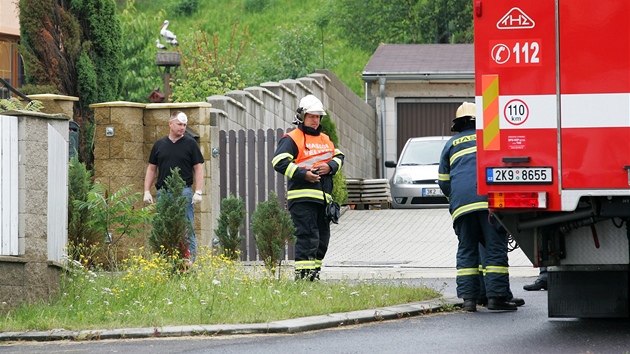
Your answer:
[149,167,193,259]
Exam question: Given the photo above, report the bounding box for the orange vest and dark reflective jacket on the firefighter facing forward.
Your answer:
[271,124,344,207]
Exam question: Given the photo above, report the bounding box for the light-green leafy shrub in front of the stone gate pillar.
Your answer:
[73,183,153,269]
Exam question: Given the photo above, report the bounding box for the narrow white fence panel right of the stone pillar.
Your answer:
[48,124,68,262]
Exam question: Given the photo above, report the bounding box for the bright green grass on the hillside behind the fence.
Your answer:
[128,0,372,96]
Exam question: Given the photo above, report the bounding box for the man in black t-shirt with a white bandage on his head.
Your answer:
[144,111,204,262]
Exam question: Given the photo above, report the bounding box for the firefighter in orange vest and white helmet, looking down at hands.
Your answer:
[271,95,344,281]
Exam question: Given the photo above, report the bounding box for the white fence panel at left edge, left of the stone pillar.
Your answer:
[0,115,18,256]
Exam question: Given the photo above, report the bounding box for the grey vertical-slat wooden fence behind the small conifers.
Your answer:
[219,129,295,261]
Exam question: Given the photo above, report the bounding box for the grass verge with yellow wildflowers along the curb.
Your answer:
[0,246,439,331]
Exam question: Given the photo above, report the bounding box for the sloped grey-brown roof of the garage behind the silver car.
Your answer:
[362,44,475,81]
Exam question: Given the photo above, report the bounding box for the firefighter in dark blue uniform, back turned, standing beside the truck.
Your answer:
[438,102,517,312]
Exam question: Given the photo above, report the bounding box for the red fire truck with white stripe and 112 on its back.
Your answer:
[473,0,630,318]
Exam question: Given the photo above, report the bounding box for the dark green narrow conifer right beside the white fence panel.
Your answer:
[68,155,103,266]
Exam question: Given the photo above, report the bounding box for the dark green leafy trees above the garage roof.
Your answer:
[333,0,473,52]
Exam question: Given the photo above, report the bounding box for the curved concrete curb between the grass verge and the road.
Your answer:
[0,294,462,342]
